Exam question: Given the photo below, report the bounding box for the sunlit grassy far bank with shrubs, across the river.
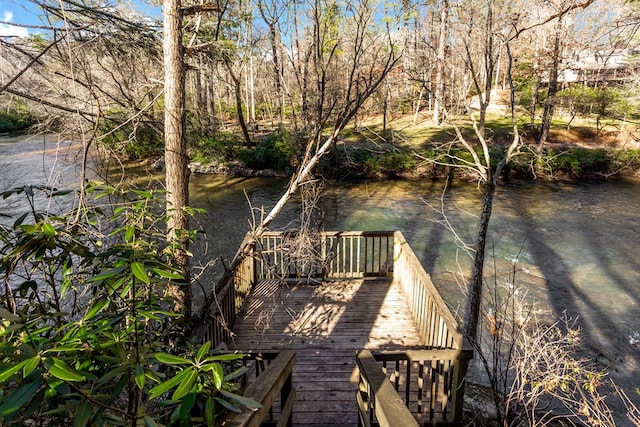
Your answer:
[190,108,640,179]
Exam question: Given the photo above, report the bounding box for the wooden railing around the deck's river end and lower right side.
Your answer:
[206,231,472,425]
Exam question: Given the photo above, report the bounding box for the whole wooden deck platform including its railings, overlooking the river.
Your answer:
[202,232,471,427]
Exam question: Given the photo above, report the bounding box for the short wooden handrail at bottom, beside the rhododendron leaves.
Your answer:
[224,350,296,427]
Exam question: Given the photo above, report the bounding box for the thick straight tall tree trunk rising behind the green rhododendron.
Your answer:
[163,0,191,317]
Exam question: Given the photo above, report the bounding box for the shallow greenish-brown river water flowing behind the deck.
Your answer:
[0,138,640,418]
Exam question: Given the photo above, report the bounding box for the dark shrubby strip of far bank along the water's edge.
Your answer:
[178,144,640,182]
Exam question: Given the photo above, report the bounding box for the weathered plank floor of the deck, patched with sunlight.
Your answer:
[231,278,425,426]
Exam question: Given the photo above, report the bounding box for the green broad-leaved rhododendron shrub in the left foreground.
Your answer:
[0,186,259,426]
